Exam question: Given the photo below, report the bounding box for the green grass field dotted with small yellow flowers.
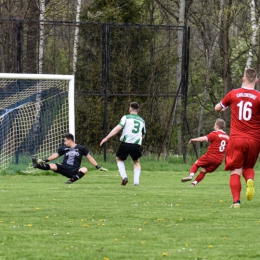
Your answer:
[0,155,260,260]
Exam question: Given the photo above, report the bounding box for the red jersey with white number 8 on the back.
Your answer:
[206,130,229,162]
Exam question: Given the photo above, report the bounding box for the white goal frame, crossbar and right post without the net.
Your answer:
[0,73,75,138]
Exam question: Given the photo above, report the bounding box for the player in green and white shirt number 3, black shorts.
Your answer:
[100,102,146,185]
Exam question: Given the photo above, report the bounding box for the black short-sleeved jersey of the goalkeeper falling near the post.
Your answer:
[58,144,90,168]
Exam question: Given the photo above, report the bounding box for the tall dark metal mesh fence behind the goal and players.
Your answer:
[0,19,189,158]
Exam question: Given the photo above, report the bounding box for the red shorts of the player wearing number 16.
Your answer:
[225,138,260,171]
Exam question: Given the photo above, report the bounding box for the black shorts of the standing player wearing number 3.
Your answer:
[116,142,142,161]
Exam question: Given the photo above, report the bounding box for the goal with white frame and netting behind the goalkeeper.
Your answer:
[0,73,75,173]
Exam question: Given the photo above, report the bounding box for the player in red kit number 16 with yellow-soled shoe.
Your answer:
[215,68,260,208]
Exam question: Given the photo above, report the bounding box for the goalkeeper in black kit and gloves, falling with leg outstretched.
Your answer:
[32,133,107,184]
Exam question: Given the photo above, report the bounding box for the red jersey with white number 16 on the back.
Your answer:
[220,86,260,141]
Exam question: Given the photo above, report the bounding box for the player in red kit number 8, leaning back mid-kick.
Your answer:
[181,119,229,186]
